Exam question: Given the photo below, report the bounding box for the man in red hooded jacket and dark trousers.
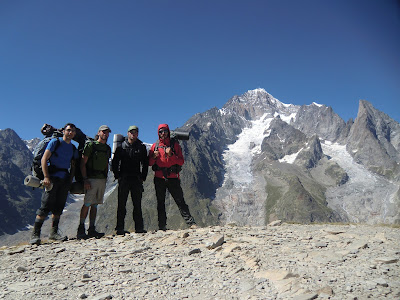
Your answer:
[149,124,197,231]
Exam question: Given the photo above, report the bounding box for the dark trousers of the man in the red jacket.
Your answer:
[154,177,195,228]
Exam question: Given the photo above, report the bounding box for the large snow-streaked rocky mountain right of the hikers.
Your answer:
[182,89,400,225]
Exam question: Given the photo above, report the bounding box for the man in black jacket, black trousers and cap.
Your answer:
[112,125,149,235]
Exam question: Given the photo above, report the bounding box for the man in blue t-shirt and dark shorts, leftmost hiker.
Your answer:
[30,123,78,245]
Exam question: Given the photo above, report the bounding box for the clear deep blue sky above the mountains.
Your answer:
[0,0,400,143]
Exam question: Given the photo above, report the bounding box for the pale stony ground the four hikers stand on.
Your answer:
[0,221,400,300]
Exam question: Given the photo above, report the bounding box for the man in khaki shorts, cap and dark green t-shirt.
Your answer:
[76,125,111,239]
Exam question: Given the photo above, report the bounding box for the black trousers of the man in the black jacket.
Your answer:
[115,177,144,231]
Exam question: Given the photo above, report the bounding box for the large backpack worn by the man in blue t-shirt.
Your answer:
[31,136,76,180]
